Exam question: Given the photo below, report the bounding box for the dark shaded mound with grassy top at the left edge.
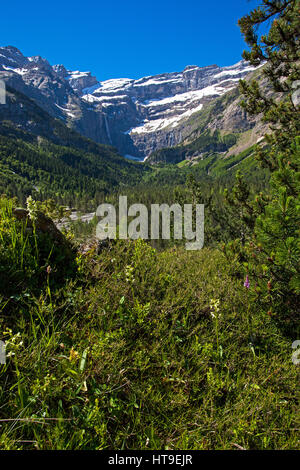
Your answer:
[0,197,76,299]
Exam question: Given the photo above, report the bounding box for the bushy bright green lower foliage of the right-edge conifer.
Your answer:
[253,138,300,322]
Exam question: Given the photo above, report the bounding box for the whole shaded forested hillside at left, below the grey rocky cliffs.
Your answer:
[0,88,147,210]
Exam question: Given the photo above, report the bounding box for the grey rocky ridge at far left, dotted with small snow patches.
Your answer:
[0,46,110,144]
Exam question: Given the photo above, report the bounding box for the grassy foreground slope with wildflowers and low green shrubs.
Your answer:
[0,199,299,449]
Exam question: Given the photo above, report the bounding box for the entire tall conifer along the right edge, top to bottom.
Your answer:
[227,0,300,324]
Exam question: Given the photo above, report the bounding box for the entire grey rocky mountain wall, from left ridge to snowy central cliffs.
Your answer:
[0,46,262,160]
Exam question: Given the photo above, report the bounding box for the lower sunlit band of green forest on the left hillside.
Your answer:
[0,129,144,210]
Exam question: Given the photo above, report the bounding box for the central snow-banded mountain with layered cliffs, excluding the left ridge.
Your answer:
[82,61,254,157]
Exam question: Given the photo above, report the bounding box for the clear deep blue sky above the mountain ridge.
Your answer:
[0,0,260,80]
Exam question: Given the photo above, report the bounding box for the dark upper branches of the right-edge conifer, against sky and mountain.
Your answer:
[239,0,300,165]
